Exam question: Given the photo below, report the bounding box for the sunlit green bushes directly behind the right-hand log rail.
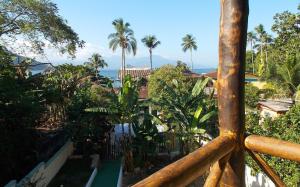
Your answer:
[246,105,300,186]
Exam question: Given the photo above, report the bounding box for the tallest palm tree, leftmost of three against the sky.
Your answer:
[108,18,137,84]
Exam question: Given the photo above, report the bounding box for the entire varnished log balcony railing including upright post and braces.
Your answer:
[134,0,300,187]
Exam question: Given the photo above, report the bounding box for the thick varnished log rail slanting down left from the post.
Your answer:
[134,136,235,187]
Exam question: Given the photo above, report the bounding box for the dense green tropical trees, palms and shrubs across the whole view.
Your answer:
[0,0,300,186]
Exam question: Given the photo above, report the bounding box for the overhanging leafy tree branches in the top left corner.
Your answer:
[0,0,84,57]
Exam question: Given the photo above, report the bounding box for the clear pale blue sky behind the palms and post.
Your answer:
[48,0,300,68]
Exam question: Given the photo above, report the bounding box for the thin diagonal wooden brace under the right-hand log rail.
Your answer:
[247,150,285,187]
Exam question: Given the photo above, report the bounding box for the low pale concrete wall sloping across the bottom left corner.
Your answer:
[5,141,74,187]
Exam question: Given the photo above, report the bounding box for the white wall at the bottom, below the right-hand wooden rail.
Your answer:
[245,166,275,187]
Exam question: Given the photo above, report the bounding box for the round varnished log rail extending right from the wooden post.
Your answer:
[245,135,300,162]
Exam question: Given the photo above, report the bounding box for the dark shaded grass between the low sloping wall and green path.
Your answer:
[48,158,92,187]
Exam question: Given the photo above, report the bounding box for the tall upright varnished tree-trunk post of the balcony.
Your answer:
[217,0,249,187]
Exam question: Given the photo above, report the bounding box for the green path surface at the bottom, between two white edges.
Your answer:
[92,159,121,187]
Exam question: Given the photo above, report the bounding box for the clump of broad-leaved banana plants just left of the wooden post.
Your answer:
[152,79,216,154]
